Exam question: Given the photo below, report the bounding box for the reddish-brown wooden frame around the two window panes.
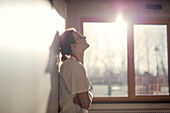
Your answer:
[80,17,170,103]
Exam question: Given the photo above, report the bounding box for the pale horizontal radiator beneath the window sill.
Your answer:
[89,103,170,113]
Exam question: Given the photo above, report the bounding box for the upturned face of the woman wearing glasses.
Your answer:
[73,31,89,51]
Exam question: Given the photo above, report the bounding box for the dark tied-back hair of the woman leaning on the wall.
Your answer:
[60,28,76,62]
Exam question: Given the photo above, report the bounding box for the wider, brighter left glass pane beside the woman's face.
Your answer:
[83,22,128,97]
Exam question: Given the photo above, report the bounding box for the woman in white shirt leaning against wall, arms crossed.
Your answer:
[59,28,93,113]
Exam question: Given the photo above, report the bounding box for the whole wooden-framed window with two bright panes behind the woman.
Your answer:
[81,18,170,102]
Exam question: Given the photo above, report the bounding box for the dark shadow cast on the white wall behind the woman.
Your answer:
[46,31,59,113]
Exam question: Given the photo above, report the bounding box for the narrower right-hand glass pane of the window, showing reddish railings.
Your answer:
[134,25,169,95]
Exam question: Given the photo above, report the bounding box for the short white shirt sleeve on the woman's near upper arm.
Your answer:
[61,59,90,94]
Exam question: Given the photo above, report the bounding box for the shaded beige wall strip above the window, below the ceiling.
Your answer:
[66,0,170,31]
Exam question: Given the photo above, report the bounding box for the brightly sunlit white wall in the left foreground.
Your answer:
[0,0,65,113]
